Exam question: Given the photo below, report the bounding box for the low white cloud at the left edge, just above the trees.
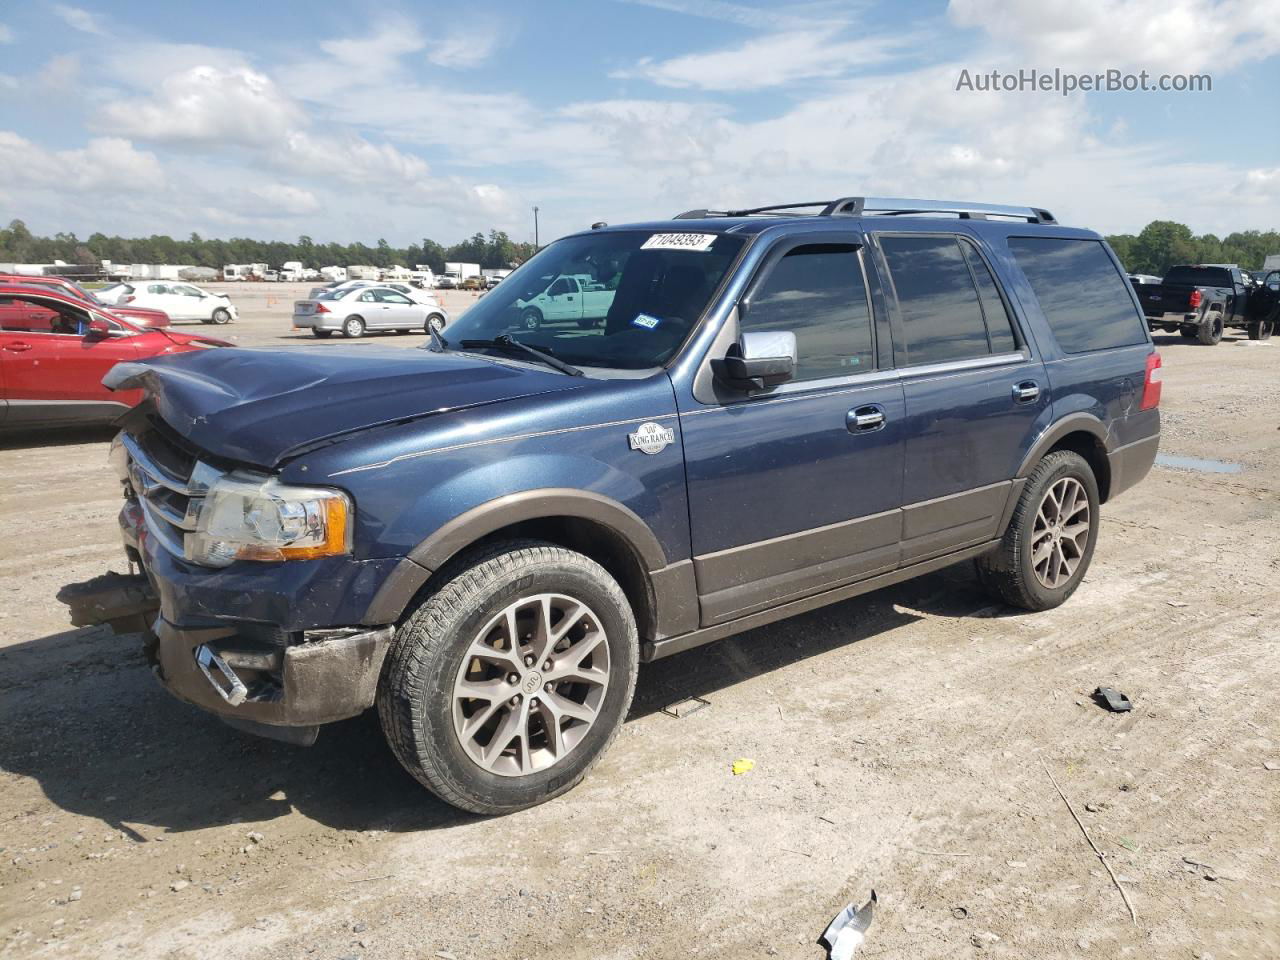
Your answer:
[0,131,164,192]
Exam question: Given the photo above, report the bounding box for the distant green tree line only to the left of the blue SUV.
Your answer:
[0,220,534,273]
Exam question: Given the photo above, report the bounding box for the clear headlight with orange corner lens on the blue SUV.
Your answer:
[186,474,353,567]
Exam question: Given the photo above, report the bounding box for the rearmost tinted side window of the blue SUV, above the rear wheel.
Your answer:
[1009,237,1147,353]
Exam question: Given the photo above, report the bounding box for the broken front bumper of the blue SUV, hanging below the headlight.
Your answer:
[59,488,393,744]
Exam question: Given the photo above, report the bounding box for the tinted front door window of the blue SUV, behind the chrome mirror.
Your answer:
[741,243,874,380]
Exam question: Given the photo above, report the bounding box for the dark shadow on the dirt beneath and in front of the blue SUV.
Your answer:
[0,564,1011,840]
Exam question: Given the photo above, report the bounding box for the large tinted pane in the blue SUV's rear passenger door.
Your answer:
[881,237,991,366]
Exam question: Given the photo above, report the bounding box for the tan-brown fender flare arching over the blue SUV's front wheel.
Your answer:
[364,486,668,632]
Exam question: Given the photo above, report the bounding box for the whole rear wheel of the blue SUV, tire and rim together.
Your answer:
[977,451,1098,611]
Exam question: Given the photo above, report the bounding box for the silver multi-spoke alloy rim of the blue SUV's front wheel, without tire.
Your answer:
[453,594,611,777]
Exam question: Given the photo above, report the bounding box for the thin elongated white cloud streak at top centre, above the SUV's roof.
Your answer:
[613,31,911,91]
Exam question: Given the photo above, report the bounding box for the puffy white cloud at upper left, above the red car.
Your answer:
[101,65,302,146]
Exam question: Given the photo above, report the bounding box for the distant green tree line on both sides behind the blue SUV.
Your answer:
[0,220,1280,276]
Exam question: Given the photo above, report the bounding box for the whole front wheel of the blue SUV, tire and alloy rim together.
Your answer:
[378,540,640,814]
